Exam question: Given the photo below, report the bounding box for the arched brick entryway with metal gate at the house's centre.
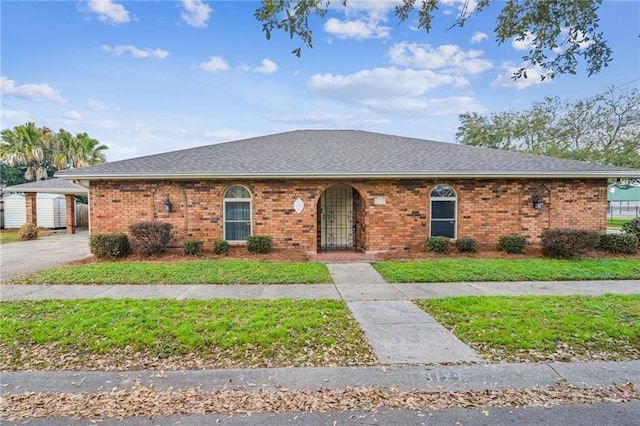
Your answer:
[317,184,365,252]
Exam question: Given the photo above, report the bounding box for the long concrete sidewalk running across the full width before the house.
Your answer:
[0,280,640,301]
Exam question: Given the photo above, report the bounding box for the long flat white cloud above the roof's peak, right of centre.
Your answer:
[308,68,468,104]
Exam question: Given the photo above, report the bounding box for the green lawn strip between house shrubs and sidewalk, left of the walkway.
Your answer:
[13,260,332,284]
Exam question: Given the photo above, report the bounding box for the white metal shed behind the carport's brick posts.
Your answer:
[4,193,67,228]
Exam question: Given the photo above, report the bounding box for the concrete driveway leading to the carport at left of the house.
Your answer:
[0,230,91,282]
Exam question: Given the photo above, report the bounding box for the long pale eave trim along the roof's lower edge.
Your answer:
[56,170,640,180]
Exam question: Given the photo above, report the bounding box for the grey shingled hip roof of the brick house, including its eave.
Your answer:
[56,130,640,180]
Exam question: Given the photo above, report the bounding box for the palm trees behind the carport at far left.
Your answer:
[0,122,108,184]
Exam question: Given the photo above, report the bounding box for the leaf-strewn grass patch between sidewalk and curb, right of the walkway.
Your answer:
[417,295,640,362]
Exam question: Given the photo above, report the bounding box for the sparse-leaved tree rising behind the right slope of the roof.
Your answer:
[456,87,640,168]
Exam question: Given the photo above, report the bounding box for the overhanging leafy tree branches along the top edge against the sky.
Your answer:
[255,0,613,79]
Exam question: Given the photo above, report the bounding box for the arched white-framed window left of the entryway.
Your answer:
[224,185,251,241]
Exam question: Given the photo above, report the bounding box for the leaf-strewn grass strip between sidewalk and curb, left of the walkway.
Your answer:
[0,299,375,370]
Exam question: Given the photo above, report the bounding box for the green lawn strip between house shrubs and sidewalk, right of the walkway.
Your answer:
[374,258,640,283]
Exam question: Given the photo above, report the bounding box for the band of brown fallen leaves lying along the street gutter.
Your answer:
[0,383,640,421]
